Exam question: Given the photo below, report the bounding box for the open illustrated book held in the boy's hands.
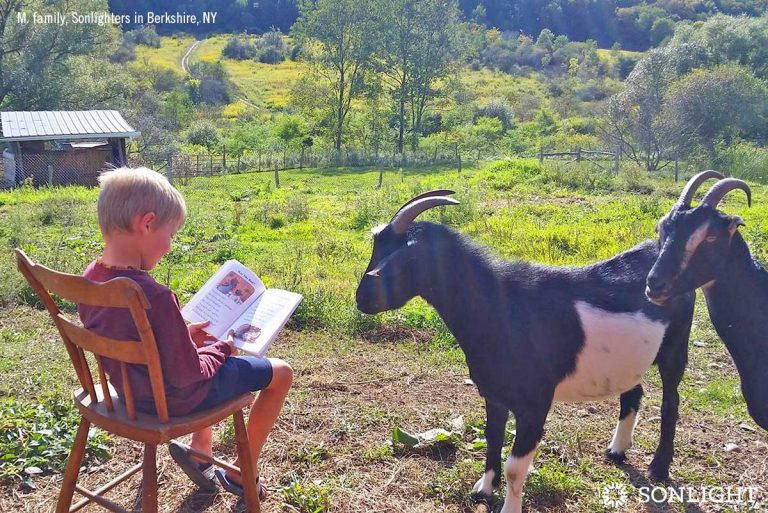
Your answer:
[181,260,302,356]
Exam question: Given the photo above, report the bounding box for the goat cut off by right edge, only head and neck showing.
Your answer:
[646,171,768,429]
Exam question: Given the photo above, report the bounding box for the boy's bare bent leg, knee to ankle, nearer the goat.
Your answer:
[227,358,293,483]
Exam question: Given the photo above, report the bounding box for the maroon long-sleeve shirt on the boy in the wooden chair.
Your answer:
[78,261,231,416]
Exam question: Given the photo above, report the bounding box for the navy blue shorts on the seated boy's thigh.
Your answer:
[192,356,272,411]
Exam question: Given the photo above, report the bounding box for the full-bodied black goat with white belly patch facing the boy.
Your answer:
[356,190,694,513]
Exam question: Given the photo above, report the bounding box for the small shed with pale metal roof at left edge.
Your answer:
[0,110,141,186]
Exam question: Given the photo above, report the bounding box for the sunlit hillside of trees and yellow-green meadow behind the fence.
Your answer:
[0,0,768,180]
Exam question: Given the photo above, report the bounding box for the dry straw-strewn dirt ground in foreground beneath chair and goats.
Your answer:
[0,332,768,513]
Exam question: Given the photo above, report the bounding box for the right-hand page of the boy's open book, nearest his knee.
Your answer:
[232,289,303,356]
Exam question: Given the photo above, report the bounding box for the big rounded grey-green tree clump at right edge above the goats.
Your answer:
[605,16,768,171]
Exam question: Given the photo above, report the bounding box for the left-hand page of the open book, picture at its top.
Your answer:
[181,260,266,340]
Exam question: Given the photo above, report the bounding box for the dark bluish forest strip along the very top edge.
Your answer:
[109,0,768,50]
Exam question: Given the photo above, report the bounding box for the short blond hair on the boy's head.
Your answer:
[97,167,187,234]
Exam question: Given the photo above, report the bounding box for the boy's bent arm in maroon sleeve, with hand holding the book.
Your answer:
[147,290,231,388]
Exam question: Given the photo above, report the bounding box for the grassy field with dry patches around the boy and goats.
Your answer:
[0,161,768,513]
